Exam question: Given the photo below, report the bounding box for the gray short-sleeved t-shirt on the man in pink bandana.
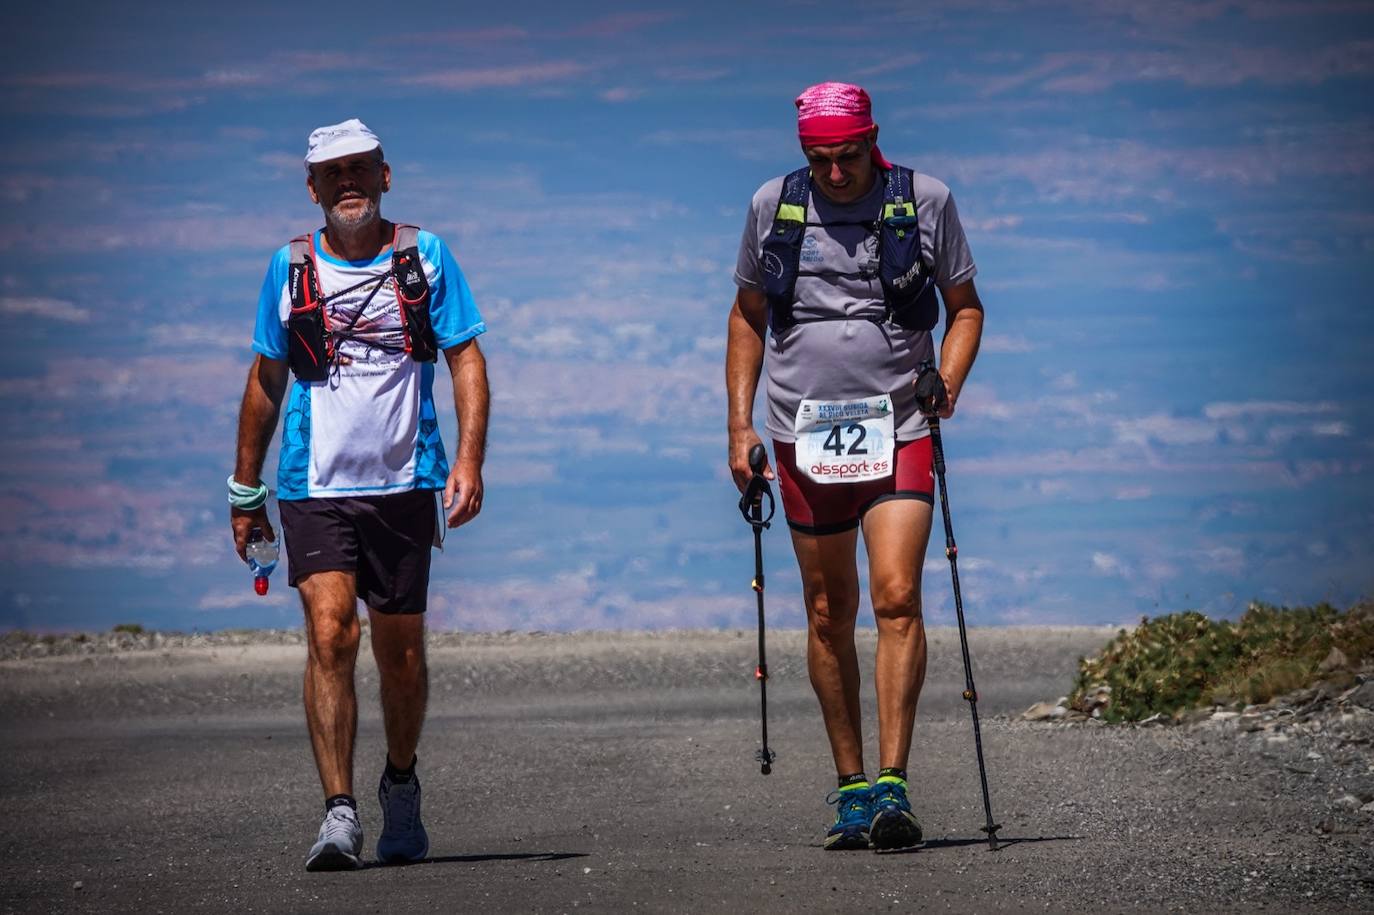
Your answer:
[735,172,977,442]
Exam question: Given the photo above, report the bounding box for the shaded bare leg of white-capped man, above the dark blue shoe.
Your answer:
[367,607,429,769]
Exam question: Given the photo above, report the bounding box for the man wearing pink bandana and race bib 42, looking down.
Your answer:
[725,82,982,850]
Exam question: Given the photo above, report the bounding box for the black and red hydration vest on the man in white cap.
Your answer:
[286,224,438,382]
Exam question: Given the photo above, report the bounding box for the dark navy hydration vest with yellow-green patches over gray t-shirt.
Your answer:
[763,165,940,335]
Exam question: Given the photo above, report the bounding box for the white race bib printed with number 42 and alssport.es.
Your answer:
[794,394,896,484]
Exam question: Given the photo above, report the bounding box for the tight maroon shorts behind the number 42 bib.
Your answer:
[774,436,936,534]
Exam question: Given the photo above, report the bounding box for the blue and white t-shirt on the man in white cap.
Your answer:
[253,231,486,500]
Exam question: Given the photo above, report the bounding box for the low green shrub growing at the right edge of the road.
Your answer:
[1070,603,1374,721]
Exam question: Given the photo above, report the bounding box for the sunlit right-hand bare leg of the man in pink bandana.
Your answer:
[863,499,932,769]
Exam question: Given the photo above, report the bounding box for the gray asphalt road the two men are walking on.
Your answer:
[0,629,1374,912]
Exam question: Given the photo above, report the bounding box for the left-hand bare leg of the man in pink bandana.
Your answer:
[791,529,863,776]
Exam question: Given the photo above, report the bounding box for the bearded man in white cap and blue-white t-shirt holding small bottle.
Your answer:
[229,120,489,870]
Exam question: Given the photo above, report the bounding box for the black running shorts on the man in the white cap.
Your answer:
[278,489,438,613]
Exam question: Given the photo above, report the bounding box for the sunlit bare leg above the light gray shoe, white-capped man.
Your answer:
[298,572,360,797]
